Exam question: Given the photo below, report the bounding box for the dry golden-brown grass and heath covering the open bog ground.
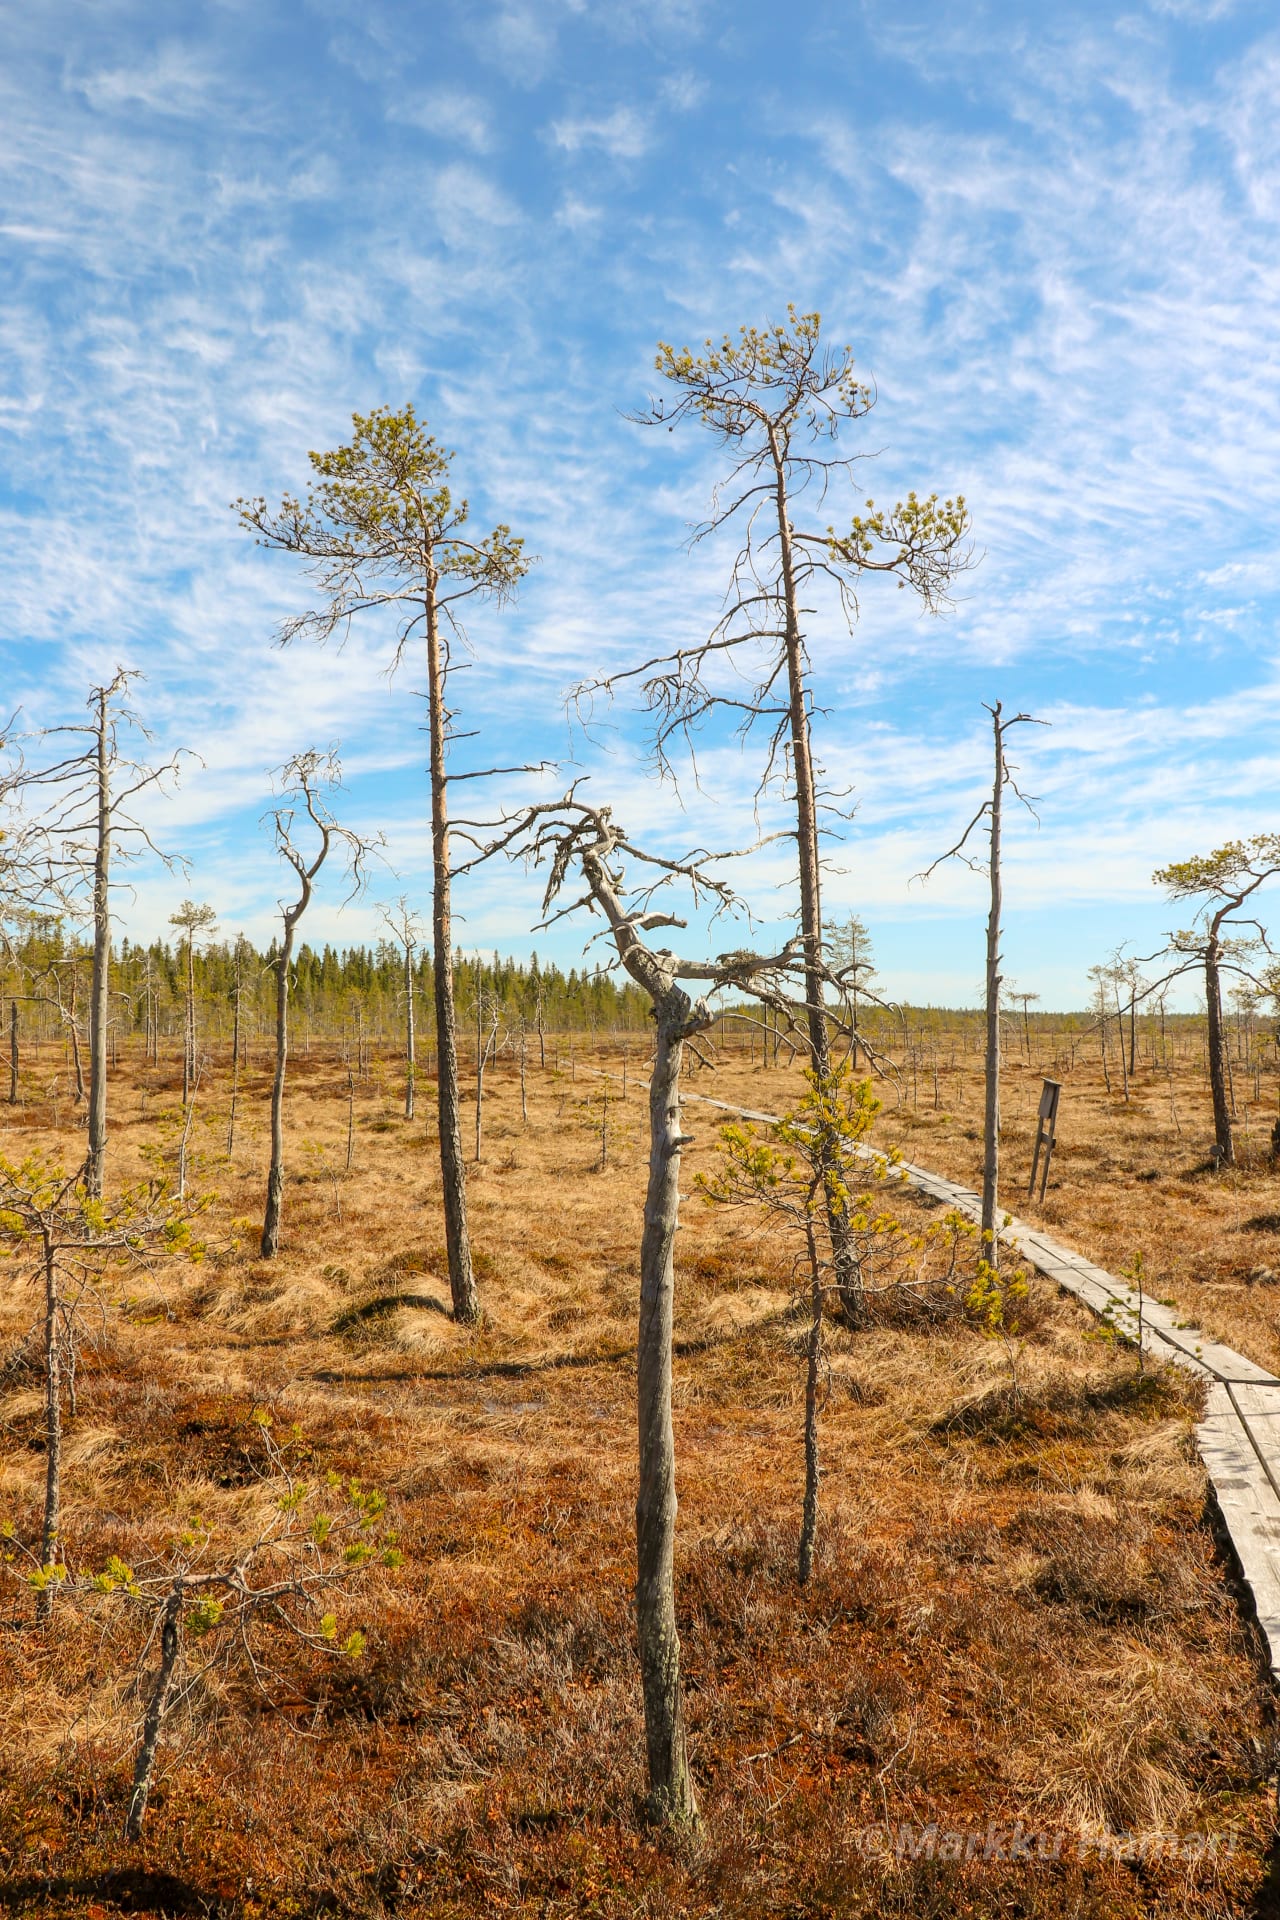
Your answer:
[0,1054,1280,1920]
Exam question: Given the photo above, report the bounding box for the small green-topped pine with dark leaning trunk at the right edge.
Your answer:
[1151,833,1280,1167]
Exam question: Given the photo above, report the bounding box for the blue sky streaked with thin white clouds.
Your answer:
[0,0,1280,1004]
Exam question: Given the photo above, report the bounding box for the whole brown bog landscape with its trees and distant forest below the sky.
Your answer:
[0,309,1280,1920]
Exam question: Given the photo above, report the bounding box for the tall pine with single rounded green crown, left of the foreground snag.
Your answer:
[236,405,535,1321]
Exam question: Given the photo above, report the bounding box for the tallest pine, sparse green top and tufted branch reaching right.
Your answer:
[574,307,971,1325]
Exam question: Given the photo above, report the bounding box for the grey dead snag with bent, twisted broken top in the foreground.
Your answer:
[482,789,798,1828]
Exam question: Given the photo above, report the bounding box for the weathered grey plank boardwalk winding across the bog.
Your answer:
[681,1092,1280,1682]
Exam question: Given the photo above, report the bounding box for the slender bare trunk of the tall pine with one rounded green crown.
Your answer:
[424,580,480,1323]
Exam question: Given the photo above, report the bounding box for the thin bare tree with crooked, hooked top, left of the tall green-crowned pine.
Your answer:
[261,749,378,1260]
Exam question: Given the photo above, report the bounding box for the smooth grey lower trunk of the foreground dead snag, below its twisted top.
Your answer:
[635,995,697,1826]
